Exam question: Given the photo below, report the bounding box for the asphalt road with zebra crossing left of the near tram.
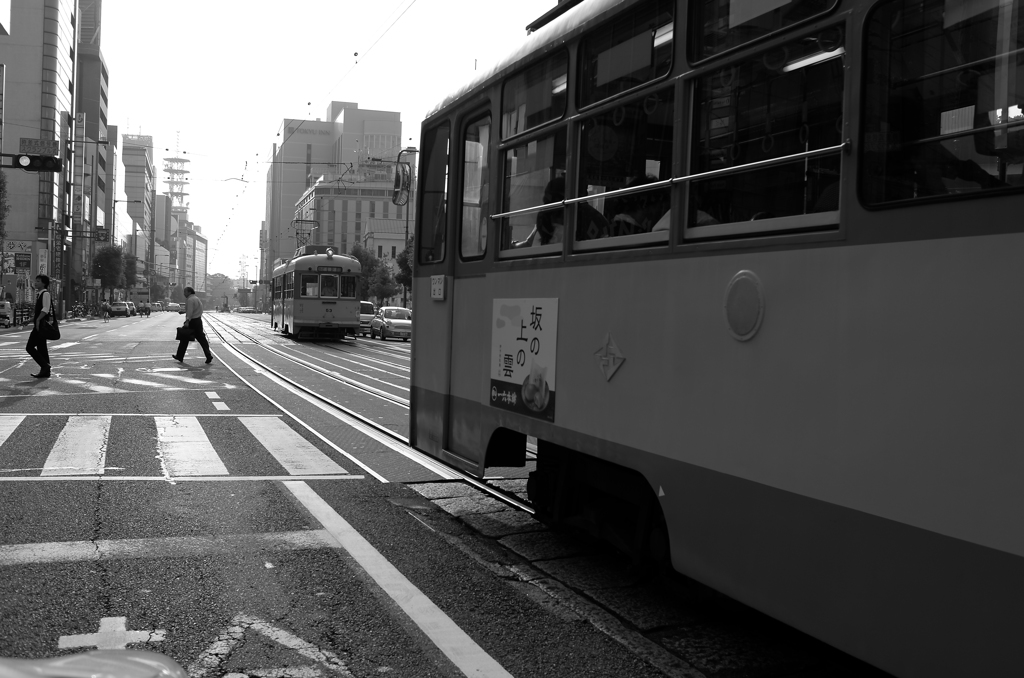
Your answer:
[0,313,663,678]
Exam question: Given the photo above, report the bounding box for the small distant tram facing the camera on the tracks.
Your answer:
[270,245,359,339]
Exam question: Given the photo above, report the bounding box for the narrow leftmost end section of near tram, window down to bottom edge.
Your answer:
[408,121,455,459]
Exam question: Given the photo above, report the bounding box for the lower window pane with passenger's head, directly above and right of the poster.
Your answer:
[501,128,565,254]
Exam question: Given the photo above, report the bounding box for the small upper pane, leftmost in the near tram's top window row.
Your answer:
[502,51,569,139]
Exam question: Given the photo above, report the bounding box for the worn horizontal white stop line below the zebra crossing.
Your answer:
[0,529,337,567]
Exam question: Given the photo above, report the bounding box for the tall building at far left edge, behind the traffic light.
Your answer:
[0,0,78,303]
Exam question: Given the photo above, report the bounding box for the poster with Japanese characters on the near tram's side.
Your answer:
[490,299,558,421]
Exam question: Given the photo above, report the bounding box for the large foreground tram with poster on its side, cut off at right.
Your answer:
[411,0,1024,677]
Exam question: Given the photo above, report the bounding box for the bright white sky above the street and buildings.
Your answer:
[101,0,556,278]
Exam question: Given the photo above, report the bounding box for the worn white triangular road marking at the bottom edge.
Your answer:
[188,613,352,678]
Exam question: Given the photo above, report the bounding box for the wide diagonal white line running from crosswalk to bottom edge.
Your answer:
[284,481,512,678]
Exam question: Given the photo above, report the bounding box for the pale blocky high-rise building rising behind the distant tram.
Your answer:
[259,101,404,288]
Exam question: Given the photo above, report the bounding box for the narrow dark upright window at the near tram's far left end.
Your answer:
[416,123,450,263]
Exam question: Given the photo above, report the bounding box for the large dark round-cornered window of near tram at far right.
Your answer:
[860,0,1024,205]
